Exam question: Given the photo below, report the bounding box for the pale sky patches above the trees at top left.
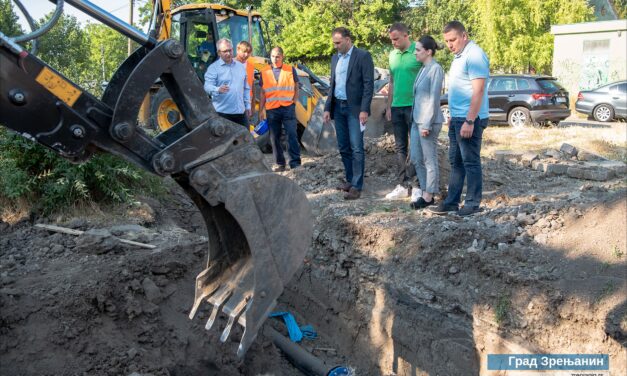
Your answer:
[13,0,147,30]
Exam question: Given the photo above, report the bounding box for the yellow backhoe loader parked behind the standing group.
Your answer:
[140,0,335,154]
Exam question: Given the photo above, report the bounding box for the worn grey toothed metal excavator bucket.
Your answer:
[176,130,312,357]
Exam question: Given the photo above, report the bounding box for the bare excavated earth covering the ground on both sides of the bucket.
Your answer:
[0,136,627,376]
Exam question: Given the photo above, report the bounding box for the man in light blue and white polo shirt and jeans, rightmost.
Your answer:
[429,21,490,216]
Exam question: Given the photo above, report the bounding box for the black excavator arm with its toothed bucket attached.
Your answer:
[0,0,312,357]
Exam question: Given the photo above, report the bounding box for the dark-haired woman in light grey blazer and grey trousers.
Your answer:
[410,35,444,209]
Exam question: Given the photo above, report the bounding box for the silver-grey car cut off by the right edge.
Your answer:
[575,81,627,121]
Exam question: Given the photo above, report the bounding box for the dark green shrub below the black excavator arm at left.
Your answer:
[0,129,161,214]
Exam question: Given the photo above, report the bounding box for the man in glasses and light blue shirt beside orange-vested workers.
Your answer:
[204,39,251,127]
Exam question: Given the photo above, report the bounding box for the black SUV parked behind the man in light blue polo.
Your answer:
[440,74,570,127]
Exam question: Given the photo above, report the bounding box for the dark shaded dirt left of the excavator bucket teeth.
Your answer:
[0,207,291,375]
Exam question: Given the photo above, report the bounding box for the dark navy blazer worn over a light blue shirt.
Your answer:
[324,47,374,119]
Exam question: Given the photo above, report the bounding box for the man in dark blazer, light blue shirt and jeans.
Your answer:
[324,27,374,200]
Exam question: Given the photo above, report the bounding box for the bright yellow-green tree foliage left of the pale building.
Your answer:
[405,0,592,73]
